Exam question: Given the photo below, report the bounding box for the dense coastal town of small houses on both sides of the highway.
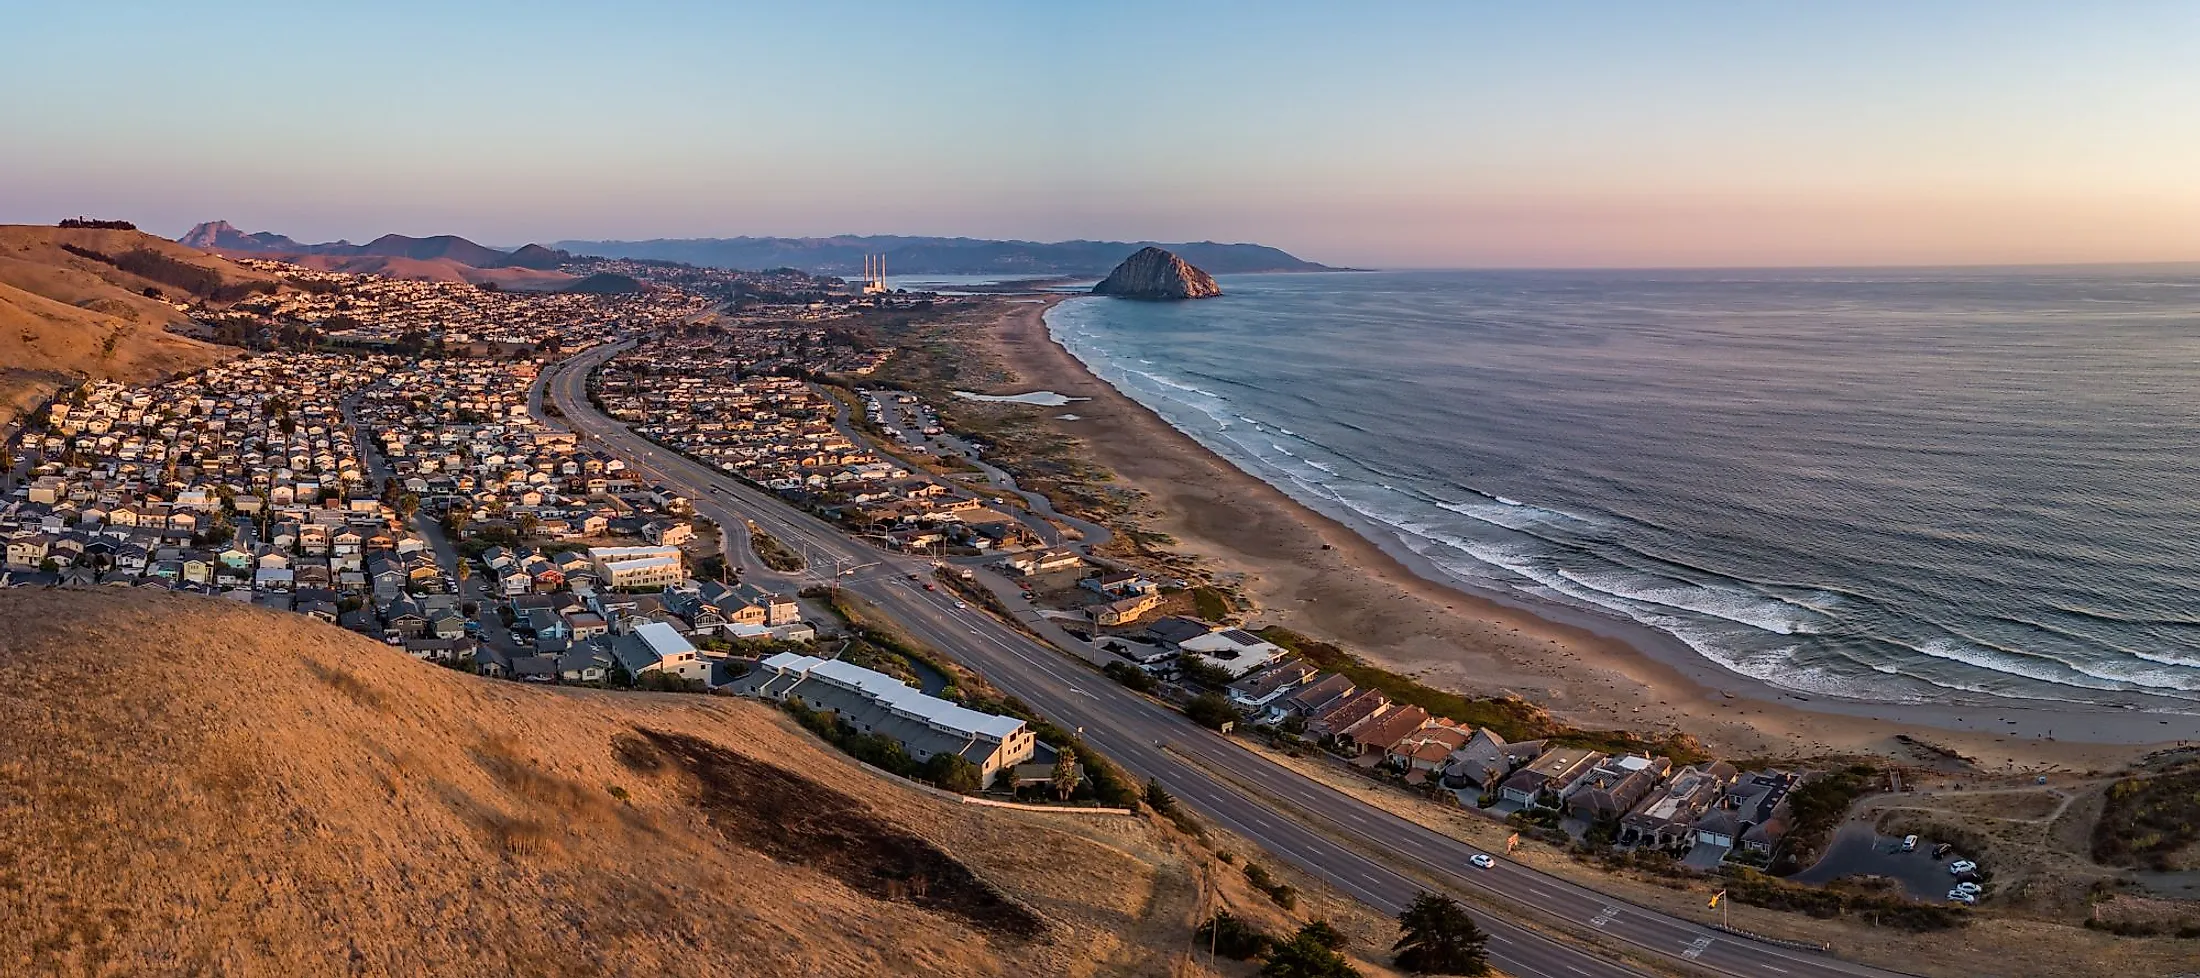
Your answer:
[0,228,2191,975]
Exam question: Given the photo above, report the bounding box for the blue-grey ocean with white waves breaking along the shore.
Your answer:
[1047,266,2200,703]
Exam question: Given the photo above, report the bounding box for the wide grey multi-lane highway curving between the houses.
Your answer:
[546,343,1899,978]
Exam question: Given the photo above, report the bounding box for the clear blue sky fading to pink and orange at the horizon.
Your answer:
[0,0,2200,266]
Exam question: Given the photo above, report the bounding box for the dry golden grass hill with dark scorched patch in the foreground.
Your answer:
[0,589,1223,976]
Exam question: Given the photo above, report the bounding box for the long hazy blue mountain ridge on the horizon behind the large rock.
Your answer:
[554,235,1335,277]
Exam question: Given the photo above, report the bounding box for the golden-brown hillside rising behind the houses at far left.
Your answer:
[0,224,259,424]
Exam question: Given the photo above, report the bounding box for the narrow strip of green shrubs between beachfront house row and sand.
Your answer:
[1258,624,1709,765]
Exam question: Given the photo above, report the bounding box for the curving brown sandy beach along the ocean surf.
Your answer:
[970,297,2200,771]
